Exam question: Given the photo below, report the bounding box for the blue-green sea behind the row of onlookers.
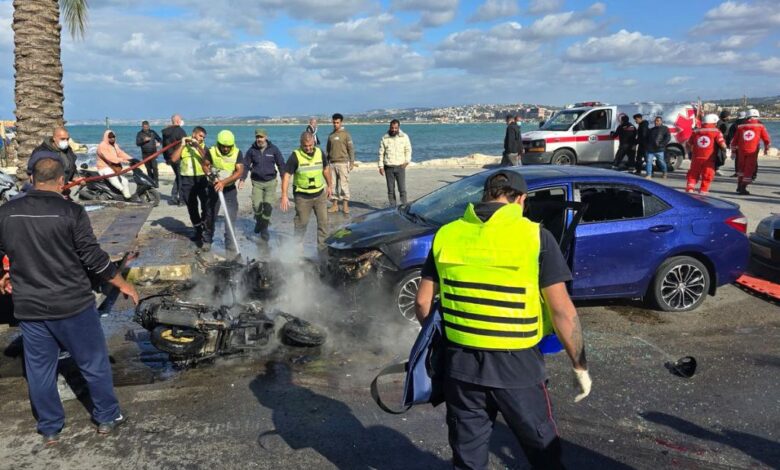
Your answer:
[68,121,780,162]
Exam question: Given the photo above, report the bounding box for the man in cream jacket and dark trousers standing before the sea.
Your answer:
[379,119,412,207]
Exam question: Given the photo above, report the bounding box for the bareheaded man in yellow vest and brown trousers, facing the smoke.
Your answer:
[280,132,333,250]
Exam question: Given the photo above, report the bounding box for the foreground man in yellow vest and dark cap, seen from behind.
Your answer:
[416,170,591,469]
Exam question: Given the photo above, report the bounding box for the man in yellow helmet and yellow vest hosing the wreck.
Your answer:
[207,130,244,259]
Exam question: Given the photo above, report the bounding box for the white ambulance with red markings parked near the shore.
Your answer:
[523,101,696,169]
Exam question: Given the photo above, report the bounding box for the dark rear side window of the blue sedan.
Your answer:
[577,184,669,223]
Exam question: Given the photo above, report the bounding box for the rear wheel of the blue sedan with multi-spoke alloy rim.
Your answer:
[650,256,710,312]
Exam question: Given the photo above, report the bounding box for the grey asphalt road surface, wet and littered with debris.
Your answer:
[0,160,780,470]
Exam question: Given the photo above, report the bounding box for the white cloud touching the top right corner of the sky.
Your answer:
[692,0,780,34]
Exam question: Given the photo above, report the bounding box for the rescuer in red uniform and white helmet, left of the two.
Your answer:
[685,114,726,194]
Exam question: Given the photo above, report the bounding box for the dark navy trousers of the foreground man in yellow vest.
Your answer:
[445,378,563,469]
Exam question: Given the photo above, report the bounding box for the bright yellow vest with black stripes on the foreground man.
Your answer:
[433,204,549,350]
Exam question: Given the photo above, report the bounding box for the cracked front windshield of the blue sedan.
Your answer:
[405,174,487,225]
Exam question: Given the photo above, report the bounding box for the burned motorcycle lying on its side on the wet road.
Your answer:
[134,295,326,366]
